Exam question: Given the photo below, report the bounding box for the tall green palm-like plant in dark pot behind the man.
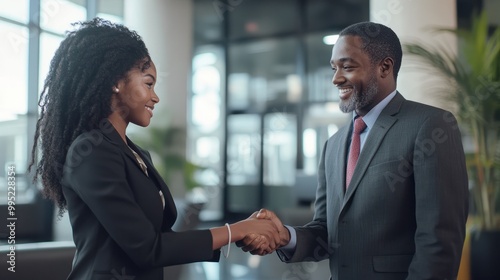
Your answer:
[403,9,500,279]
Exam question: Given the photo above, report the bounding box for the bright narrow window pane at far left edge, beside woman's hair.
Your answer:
[0,19,29,201]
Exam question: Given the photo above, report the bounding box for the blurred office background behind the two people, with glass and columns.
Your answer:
[0,0,500,280]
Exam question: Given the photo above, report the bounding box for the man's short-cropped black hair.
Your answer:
[339,22,403,79]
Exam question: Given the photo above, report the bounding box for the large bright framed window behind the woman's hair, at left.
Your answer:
[0,0,124,243]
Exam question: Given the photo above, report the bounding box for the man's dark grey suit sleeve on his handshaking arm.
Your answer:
[278,142,329,263]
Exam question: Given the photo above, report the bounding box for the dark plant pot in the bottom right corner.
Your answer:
[470,230,500,280]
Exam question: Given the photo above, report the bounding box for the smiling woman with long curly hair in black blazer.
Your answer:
[30,18,280,280]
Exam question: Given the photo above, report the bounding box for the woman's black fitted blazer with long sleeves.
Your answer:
[62,120,220,280]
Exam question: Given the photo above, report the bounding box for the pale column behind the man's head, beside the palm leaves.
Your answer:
[370,0,457,109]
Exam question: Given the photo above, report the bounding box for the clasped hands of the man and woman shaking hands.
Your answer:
[236,209,290,256]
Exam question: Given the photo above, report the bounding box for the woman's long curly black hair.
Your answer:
[29,18,151,215]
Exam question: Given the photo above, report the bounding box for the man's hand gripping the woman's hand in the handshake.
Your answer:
[236,209,290,256]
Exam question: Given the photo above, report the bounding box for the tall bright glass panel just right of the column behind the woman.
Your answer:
[187,45,225,220]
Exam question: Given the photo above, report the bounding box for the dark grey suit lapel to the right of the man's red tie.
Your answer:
[342,92,405,207]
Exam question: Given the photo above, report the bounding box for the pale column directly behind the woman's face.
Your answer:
[124,0,193,197]
